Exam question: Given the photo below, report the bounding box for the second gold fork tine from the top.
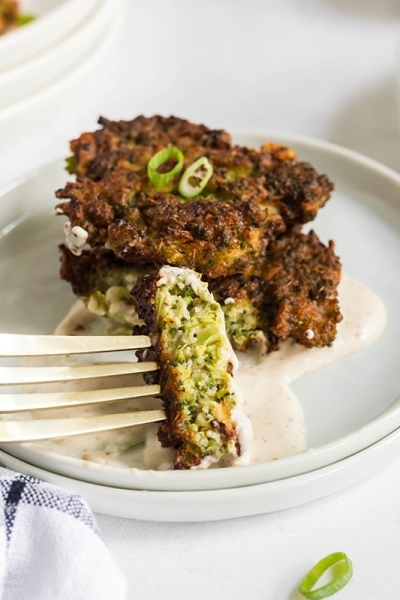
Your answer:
[0,362,159,385]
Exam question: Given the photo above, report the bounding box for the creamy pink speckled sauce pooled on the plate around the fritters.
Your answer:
[32,275,386,470]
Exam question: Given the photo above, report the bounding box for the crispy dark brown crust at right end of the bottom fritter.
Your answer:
[210,230,342,351]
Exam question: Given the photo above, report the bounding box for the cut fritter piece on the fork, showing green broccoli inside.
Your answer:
[132,266,251,469]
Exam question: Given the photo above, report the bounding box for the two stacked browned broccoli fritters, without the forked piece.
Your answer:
[56,116,341,351]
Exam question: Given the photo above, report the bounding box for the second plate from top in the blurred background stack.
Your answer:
[0,0,115,109]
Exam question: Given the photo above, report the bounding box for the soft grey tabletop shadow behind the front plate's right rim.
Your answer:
[329,80,400,171]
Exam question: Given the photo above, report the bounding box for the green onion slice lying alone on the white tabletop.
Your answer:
[299,552,353,600]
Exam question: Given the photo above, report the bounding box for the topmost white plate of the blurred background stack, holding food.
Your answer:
[0,0,102,72]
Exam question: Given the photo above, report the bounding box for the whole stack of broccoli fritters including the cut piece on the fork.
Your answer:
[56,116,342,469]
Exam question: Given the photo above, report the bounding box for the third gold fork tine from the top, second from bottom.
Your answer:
[0,385,160,413]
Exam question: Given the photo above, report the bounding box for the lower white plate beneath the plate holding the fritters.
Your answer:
[0,429,400,522]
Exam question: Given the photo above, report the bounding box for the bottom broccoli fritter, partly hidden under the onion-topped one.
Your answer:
[61,230,342,351]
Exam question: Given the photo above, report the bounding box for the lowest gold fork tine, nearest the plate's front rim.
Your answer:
[0,410,165,444]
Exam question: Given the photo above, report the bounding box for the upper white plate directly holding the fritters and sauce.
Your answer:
[0,133,400,491]
